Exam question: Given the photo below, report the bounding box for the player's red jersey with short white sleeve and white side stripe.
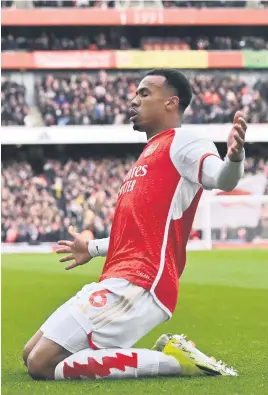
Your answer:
[101,128,219,315]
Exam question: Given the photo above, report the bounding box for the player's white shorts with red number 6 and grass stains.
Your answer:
[41,278,169,353]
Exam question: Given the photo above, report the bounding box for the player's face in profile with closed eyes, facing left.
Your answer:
[130,75,167,132]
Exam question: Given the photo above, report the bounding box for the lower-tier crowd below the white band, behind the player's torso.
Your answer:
[1,156,268,243]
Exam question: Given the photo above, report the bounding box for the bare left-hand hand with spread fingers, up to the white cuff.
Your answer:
[56,226,92,270]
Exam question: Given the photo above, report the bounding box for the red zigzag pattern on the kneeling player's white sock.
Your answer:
[63,352,138,379]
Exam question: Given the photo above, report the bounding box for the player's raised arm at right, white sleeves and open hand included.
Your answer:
[170,111,247,191]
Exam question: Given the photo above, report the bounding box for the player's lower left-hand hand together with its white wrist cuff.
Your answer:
[56,227,110,270]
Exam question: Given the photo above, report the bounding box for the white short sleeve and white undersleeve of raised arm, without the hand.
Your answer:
[170,128,244,191]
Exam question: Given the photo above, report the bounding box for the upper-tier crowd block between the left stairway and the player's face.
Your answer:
[36,71,134,126]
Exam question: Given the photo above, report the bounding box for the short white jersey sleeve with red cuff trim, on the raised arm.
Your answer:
[170,129,221,186]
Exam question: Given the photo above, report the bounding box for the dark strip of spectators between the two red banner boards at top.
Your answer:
[1,28,268,52]
